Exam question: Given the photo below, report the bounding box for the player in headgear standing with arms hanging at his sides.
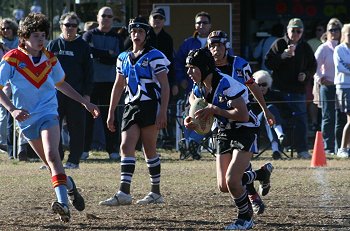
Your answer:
[100,17,170,206]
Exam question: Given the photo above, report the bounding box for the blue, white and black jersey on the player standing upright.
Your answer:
[117,48,170,104]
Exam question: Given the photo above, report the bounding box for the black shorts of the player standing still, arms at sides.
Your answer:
[122,100,158,131]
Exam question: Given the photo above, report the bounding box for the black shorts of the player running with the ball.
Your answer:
[216,126,259,155]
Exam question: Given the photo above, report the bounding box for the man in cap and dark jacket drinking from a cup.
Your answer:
[265,18,317,159]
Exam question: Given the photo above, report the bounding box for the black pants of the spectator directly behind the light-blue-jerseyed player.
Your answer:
[57,92,85,164]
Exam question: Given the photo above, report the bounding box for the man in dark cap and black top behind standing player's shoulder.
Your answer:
[148,7,176,149]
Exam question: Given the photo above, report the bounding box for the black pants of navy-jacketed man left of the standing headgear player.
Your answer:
[84,82,123,154]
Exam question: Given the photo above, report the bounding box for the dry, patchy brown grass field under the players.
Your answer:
[0,150,350,231]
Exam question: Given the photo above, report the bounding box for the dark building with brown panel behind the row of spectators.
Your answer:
[0,0,350,63]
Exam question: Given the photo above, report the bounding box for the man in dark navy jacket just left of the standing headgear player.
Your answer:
[81,6,124,160]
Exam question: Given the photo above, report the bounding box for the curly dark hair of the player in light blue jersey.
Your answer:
[18,13,50,46]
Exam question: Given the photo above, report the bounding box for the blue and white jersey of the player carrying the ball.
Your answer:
[192,72,260,129]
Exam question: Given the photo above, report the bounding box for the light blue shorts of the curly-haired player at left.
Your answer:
[21,114,59,140]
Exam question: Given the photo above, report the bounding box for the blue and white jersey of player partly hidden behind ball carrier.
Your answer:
[232,56,254,85]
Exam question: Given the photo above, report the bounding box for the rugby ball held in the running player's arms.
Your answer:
[189,98,214,135]
